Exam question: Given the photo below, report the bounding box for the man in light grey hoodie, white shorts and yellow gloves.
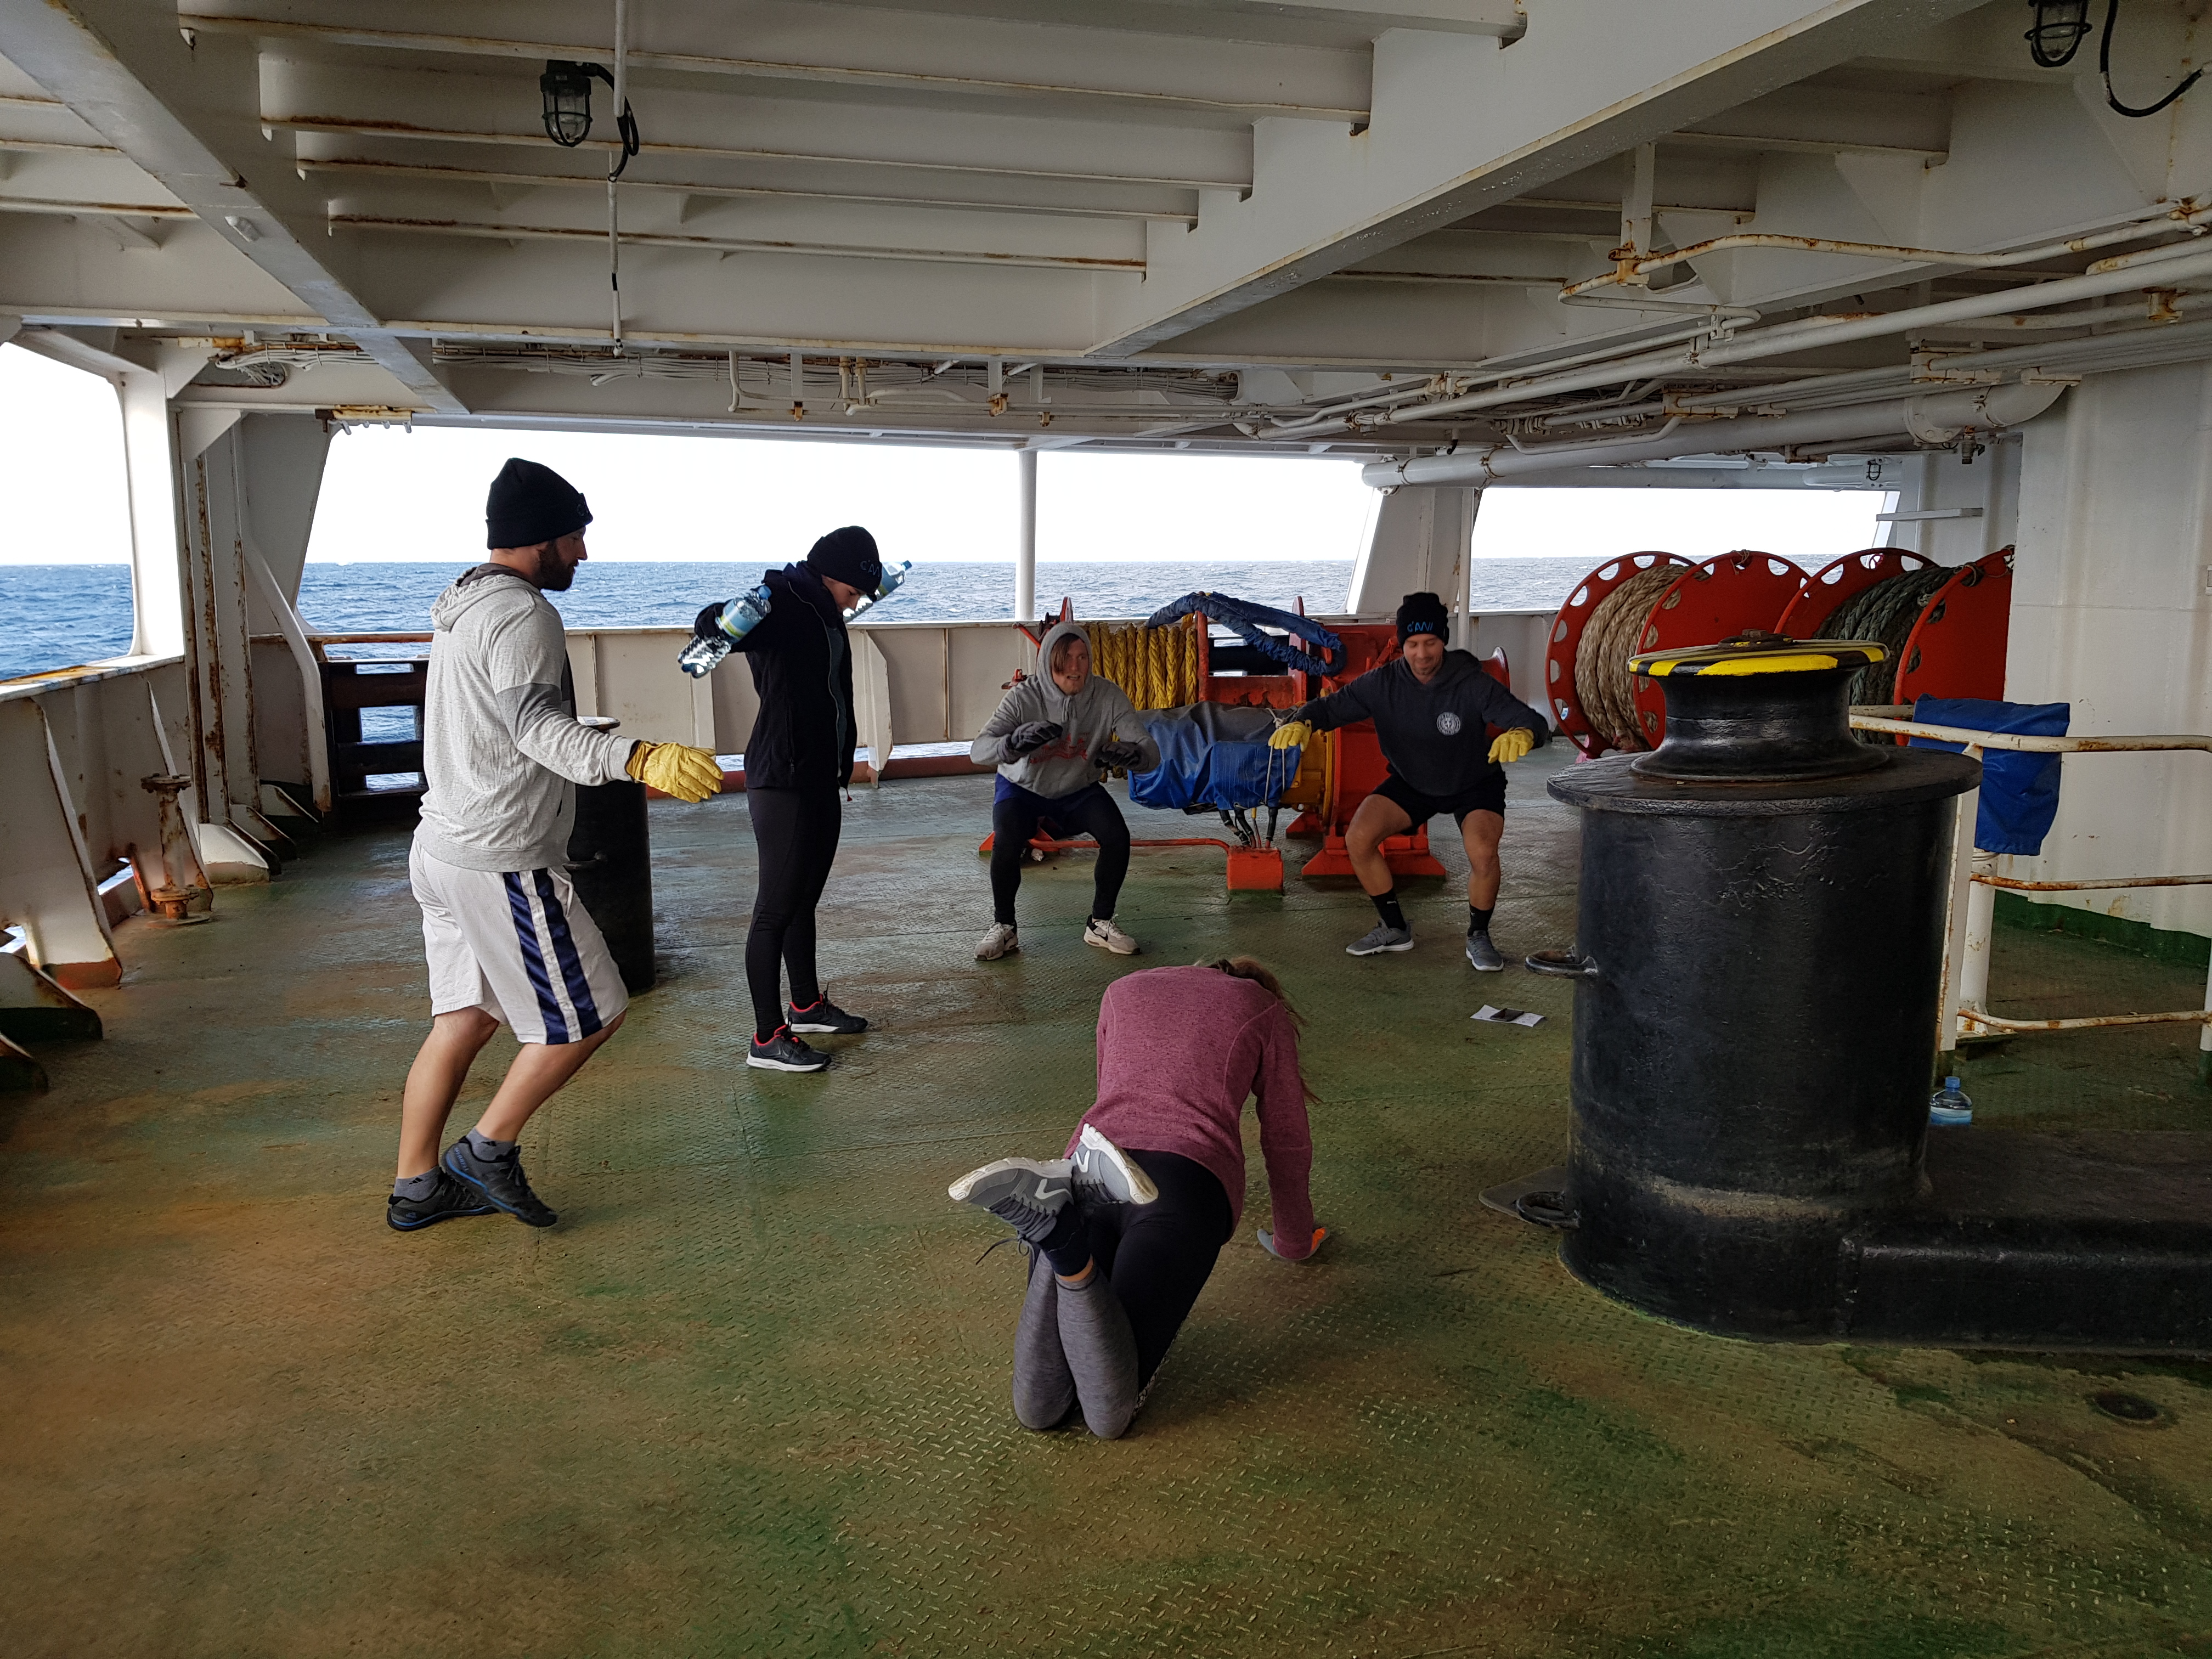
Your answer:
[385,460,721,1232]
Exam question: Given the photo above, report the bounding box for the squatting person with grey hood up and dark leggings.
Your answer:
[969,622,1159,962]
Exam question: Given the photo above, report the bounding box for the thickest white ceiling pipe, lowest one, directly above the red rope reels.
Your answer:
[1361,383,2066,489]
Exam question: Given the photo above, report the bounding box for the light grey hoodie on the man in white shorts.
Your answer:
[416,564,635,870]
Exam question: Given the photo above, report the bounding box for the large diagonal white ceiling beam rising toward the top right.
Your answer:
[1097,0,1976,356]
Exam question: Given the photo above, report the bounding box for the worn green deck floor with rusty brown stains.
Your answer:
[0,757,2212,1659]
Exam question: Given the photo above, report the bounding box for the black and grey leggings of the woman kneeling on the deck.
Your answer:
[1013,1148,1232,1440]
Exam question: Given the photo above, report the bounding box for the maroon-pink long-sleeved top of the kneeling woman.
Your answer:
[1068,967,1314,1256]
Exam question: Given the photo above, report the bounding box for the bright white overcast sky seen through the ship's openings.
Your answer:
[0,345,1882,564]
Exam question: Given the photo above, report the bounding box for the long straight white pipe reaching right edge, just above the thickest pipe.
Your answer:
[1376,248,2212,425]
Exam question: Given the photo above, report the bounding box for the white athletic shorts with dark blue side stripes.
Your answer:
[407,847,630,1044]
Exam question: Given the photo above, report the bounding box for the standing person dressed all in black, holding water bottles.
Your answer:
[695,524,883,1070]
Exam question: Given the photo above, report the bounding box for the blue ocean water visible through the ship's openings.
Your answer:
[0,557,1619,679]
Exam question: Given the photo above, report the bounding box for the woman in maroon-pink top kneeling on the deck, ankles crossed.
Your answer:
[951,956,1327,1440]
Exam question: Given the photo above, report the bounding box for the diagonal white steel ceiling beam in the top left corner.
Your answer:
[0,0,462,414]
